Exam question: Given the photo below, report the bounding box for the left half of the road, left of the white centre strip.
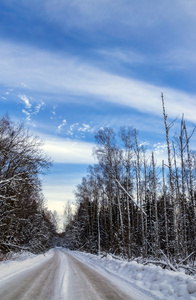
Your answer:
[0,252,61,300]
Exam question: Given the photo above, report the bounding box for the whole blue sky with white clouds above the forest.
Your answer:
[0,0,196,230]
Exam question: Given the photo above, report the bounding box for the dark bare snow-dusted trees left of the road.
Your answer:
[0,116,56,253]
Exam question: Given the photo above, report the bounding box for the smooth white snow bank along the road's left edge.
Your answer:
[0,250,53,282]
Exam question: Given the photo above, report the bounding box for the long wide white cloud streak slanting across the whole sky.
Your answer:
[0,42,196,122]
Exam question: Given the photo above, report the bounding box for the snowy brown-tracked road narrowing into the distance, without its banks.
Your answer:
[0,250,142,300]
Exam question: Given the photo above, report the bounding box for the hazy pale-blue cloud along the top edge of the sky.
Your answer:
[37,0,196,35]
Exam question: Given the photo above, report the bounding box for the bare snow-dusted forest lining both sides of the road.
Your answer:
[0,95,196,273]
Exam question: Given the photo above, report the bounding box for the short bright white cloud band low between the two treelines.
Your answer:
[43,136,95,164]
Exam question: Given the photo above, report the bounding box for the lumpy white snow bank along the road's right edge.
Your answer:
[72,251,196,300]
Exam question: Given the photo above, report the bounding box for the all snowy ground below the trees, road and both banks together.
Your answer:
[0,249,196,300]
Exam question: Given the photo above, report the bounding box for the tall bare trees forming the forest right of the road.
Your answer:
[65,96,196,262]
